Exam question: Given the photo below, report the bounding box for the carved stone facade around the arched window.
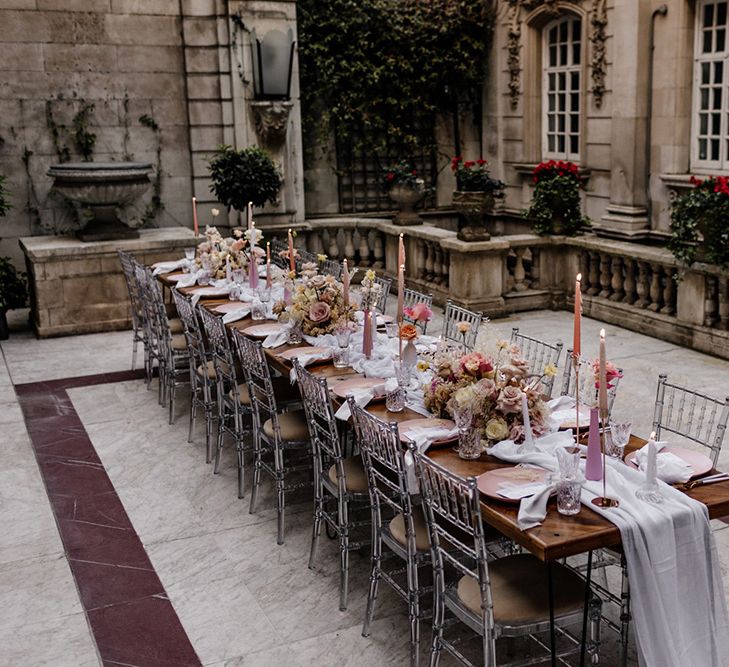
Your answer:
[482,0,699,239]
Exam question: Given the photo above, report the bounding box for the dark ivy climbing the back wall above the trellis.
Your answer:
[297,0,495,156]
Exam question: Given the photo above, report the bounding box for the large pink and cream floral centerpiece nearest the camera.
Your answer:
[424,340,556,443]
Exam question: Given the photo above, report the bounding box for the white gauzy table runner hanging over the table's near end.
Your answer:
[489,434,729,667]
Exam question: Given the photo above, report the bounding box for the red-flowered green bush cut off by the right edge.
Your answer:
[668,176,729,269]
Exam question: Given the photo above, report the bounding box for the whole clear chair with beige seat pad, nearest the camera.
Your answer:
[411,447,600,667]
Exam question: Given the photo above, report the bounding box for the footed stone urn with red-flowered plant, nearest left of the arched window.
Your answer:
[451,157,506,241]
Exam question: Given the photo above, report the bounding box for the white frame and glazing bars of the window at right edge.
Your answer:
[691,0,729,172]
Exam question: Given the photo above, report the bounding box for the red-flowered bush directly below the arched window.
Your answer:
[524,160,590,236]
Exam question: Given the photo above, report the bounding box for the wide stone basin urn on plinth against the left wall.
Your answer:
[48,162,152,241]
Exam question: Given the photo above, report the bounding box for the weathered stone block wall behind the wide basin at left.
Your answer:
[0,0,199,268]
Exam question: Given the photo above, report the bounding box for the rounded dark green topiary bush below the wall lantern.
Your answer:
[208,145,282,211]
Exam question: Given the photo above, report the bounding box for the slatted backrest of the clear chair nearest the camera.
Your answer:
[411,447,495,648]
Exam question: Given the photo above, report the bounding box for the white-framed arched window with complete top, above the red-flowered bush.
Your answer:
[542,16,582,160]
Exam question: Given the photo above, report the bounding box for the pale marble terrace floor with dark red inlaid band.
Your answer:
[0,311,729,667]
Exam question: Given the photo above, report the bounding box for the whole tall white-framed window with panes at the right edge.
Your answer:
[691,0,729,169]
